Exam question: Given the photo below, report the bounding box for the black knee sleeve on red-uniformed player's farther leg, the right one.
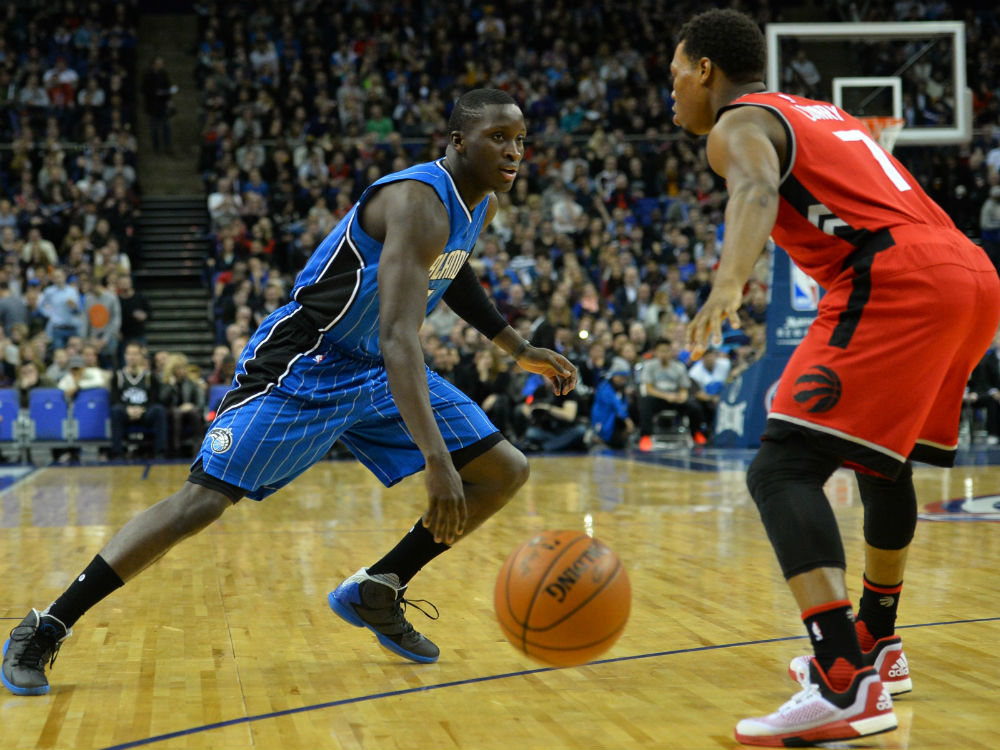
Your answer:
[856,463,917,550]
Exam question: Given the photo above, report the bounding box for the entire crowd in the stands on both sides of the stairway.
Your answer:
[0,0,1000,464]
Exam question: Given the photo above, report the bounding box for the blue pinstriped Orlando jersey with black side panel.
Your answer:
[292,159,489,357]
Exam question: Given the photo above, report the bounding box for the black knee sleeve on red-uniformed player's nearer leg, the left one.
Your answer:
[747,440,847,579]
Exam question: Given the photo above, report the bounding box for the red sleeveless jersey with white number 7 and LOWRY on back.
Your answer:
[720,93,955,288]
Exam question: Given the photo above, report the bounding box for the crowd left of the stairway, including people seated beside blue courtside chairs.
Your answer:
[0,0,225,458]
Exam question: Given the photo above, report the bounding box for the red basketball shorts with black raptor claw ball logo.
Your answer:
[764,227,1000,478]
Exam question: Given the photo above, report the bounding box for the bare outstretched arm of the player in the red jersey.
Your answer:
[687,107,785,359]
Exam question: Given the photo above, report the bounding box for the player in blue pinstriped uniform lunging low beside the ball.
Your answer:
[3,89,576,695]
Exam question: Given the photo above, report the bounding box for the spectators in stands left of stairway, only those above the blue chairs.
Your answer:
[0,0,139,372]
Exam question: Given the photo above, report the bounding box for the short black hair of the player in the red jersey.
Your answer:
[679,8,767,83]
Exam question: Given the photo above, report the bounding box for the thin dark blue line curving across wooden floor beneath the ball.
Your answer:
[94,617,1000,750]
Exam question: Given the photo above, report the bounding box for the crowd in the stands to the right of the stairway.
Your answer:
[197,0,1000,450]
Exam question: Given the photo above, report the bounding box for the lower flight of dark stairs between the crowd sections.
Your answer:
[132,195,215,375]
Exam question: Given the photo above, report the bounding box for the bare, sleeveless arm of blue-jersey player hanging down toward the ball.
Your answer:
[376,181,468,544]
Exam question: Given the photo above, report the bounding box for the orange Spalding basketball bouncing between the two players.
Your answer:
[493,531,632,667]
